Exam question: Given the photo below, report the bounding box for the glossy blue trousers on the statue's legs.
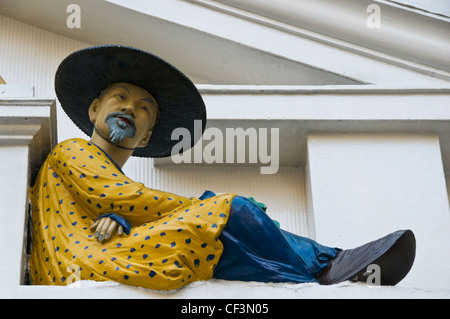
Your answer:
[213,193,340,283]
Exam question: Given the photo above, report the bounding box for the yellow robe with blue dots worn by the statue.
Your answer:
[30,139,235,290]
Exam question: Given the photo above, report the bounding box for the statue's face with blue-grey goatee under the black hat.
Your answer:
[89,83,158,148]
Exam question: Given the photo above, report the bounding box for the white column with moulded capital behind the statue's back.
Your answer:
[0,85,56,297]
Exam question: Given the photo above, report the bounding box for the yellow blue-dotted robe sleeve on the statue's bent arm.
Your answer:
[50,139,200,226]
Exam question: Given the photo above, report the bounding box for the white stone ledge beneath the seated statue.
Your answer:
[8,279,450,298]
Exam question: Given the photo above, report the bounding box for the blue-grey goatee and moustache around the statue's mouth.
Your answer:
[105,112,136,146]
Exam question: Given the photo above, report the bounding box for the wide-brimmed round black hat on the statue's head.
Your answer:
[55,45,206,157]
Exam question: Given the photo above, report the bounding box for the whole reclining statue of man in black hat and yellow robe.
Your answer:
[30,45,415,290]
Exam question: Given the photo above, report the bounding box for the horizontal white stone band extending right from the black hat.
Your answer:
[198,85,450,121]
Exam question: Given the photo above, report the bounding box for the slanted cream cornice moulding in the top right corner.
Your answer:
[210,0,450,77]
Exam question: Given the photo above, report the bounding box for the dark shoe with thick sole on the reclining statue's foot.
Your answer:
[317,230,416,286]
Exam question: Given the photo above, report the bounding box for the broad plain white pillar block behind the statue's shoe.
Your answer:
[306,134,450,288]
